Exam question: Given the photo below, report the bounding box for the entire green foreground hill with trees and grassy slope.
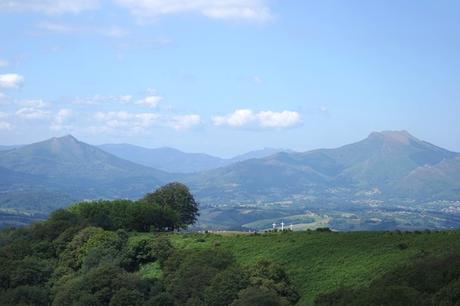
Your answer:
[0,184,460,306]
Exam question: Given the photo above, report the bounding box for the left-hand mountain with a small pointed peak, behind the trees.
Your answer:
[0,136,169,218]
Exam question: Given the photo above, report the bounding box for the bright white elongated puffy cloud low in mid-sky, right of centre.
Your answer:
[212,109,300,128]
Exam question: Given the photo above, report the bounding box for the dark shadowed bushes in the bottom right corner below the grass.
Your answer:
[315,254,460,306]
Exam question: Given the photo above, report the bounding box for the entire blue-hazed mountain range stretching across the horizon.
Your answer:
[0,131,460,230]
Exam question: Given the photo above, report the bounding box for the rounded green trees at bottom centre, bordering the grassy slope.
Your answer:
[164,248,299,306]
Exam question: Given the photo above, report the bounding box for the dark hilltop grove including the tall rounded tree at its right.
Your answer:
[69,183,198,232]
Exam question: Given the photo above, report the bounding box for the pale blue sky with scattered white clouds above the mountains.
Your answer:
[0,0,460,157]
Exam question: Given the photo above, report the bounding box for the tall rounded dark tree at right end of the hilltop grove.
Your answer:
[142,182,199,228]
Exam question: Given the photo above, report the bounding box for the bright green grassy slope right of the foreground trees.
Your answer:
[131,231,460,305]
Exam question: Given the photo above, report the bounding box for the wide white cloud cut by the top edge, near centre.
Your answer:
[116,0,271,22]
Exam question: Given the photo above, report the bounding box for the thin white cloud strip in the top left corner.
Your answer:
[0,0,101,14]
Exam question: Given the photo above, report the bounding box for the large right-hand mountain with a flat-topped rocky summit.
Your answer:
[184,131,460,201]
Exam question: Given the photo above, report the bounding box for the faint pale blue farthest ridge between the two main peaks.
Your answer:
[98,144,285,173]
